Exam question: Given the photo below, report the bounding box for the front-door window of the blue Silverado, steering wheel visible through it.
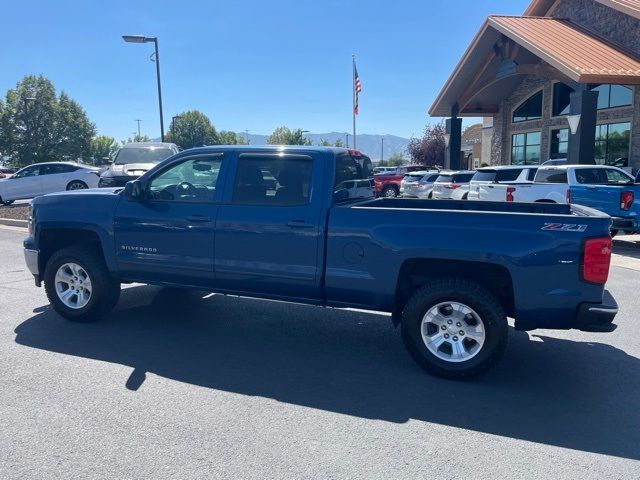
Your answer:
[149,155,222,203]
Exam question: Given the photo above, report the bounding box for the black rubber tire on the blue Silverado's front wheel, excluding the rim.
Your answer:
[44,245,120,322]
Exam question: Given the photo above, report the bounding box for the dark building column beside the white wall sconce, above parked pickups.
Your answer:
[568,85,598,164]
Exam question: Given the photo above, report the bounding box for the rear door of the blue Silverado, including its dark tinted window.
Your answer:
[215,153,323,299]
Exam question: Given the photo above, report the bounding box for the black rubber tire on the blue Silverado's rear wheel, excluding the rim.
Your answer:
[401,278,508,379]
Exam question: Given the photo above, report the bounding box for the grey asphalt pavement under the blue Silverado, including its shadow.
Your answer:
[0,229,640,480]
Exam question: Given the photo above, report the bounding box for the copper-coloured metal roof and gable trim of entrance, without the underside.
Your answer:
[429,16,640,116]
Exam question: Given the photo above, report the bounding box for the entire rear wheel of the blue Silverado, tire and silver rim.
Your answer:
[402,278,508,378]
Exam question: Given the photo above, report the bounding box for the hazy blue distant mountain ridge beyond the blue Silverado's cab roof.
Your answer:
[237,132,409,160]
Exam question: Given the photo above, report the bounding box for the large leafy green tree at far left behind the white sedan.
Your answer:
[0,75,96,166]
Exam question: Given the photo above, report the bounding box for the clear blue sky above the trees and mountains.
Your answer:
[0,0,529,139]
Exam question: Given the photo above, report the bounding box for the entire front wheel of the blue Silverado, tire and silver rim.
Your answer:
[44,245,120,322]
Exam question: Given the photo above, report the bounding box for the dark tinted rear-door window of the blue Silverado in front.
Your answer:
[233,154,312,206]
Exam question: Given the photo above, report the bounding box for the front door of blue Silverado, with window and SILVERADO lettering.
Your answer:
[114,155,224,287]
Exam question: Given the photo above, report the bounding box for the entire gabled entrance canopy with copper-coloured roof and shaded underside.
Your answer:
[429,15,640,117]
